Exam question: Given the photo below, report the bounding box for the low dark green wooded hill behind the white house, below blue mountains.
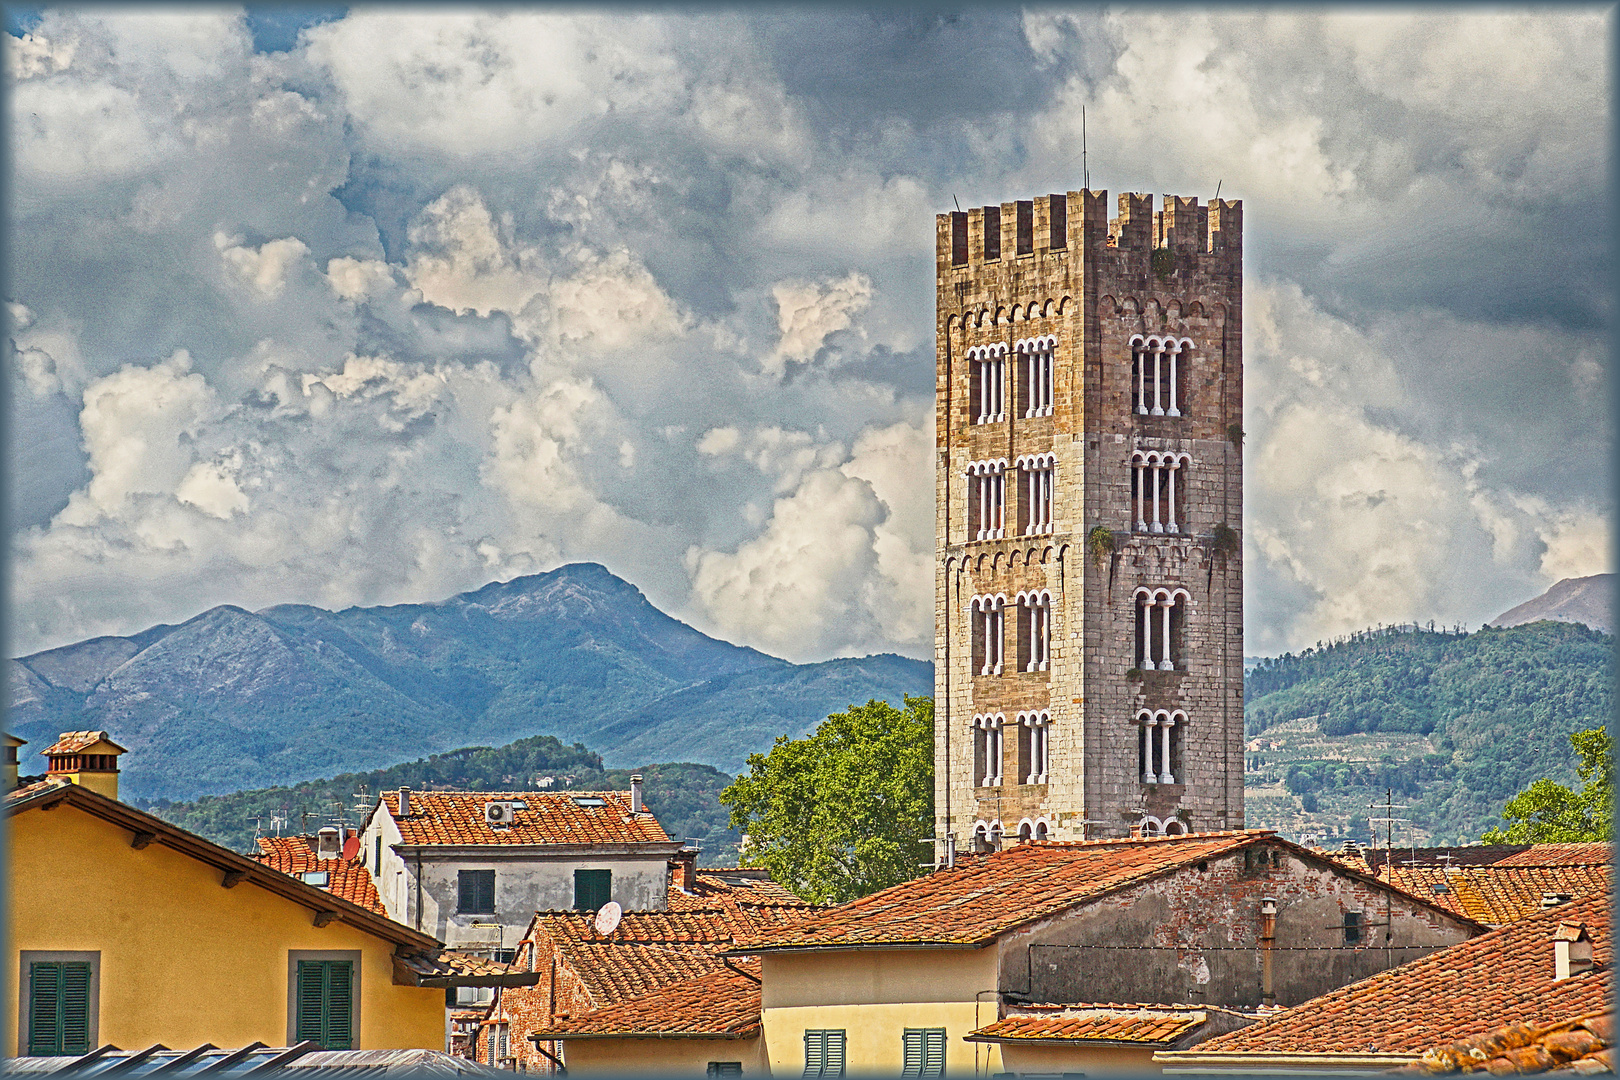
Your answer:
[144,735,739,866]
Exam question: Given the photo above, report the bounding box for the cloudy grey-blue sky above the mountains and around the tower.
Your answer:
[5,6,1612,661]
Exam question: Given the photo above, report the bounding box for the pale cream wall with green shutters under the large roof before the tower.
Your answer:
[760,946,1001,1075]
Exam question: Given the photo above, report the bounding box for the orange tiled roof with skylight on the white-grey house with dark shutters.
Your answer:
[382,792,671,847]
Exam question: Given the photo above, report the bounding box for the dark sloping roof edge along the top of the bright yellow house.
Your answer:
[5,784,442,950]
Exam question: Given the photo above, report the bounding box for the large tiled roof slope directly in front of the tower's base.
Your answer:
[739,829,1276,952]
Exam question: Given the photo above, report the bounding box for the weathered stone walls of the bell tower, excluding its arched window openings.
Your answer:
[935,191,1243,845]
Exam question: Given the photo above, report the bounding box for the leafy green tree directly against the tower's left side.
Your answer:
[719,696,933,904]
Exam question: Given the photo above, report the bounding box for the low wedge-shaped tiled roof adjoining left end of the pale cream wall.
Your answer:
[535,960,760,1040]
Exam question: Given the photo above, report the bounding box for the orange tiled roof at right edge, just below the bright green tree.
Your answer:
[1379,863,1610,926]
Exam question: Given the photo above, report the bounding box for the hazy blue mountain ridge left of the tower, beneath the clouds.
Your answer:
[6,563,933,800]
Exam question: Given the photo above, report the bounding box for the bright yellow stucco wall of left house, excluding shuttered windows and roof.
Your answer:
[9,786,444,1054]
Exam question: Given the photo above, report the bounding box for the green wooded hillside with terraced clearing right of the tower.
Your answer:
[1244,622,1614,840]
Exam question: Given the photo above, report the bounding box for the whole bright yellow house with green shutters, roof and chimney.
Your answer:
[0,732,533,1056]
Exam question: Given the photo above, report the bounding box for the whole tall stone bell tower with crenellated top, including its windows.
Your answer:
[935,191,1243,847]
